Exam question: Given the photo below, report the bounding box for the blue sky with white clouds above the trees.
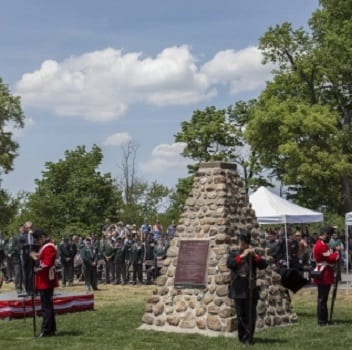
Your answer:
[0,0,318,195]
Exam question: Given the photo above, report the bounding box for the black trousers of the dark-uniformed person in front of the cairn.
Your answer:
[235,298,257,344]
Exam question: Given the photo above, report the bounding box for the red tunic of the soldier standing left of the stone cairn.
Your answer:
[35,242,59,290]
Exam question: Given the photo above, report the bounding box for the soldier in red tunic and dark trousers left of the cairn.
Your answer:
[31,229,58,337]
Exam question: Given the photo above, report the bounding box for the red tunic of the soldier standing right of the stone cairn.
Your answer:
[313,239,340,284]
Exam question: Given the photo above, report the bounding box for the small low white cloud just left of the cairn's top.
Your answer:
[139,142,191,175]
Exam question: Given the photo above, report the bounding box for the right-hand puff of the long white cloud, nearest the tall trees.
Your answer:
[201,46,273,95]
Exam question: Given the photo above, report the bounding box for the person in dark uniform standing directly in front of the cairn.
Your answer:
[227,231,267,344]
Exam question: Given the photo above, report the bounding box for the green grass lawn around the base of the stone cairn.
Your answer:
[0,285,352,350]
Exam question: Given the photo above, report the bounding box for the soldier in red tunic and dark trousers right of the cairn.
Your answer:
[312,226,340,326]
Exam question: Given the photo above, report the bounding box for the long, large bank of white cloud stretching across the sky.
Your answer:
[16,45,269,122]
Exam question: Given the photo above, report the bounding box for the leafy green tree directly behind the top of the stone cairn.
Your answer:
[174,104,270,197]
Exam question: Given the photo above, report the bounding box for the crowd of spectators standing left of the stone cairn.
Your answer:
[0,219,176,296]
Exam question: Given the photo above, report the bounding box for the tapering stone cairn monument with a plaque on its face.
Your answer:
[140,162,297,336]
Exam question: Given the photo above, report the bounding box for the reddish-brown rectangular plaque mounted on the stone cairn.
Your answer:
[174,240,209,288]
